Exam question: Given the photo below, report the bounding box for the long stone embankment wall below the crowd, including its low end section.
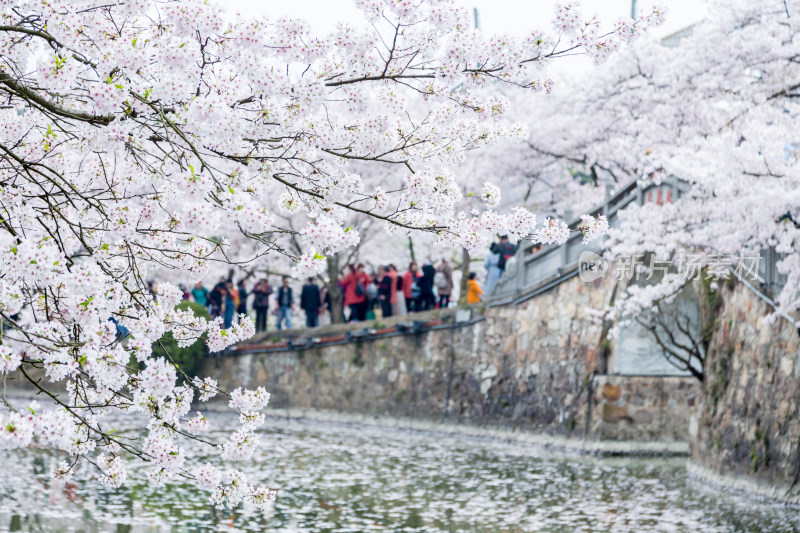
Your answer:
[205,278,696,440]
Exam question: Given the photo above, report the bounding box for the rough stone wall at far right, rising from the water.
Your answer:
[690,284,800,502]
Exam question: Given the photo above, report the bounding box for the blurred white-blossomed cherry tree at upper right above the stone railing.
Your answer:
[512,0,800,324]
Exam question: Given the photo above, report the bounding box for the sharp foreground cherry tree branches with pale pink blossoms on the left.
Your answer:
[0,0,661,506]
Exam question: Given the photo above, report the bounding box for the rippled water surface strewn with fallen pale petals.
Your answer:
[0,415,800,533]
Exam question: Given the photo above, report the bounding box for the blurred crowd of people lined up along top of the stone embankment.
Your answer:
[171,236,517,332]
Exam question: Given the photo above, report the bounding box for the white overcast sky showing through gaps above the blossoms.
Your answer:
[222,0,707,78]
